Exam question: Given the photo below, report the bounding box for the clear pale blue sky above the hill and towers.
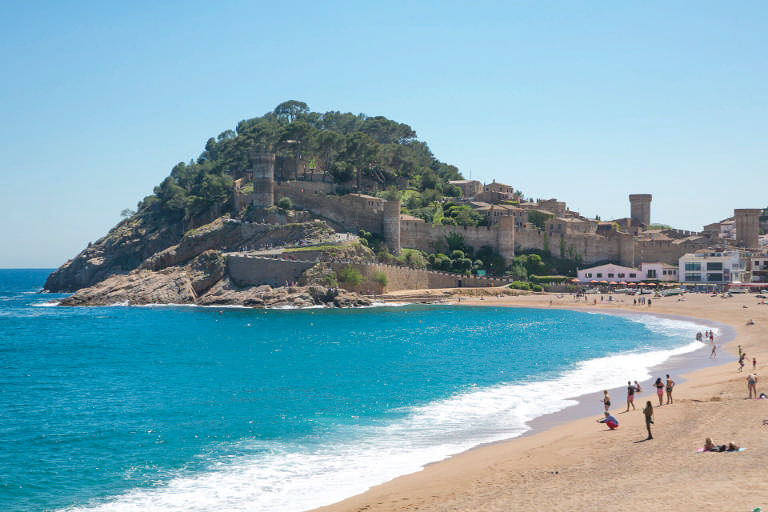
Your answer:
[0,0,768,268]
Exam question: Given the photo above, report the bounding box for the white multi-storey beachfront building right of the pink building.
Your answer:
[679,250,747,285]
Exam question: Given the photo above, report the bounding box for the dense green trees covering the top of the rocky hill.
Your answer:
[139,100,461,219]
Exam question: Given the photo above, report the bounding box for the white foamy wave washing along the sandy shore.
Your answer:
[60,332,704,512]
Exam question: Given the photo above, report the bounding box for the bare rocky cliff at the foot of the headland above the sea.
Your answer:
[45,212,370,307]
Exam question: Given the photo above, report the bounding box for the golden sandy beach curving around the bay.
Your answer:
[316,290,768,512]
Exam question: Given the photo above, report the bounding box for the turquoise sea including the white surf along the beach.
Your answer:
[0,270,717,512]
